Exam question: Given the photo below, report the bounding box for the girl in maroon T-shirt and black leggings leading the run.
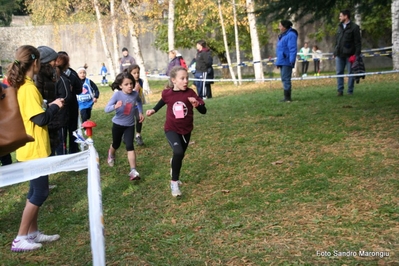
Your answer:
[146,66,206,197]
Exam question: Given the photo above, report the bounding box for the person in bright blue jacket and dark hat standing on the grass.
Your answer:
[275,20,298,102]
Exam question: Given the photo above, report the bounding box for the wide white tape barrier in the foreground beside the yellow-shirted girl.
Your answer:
[0,143,105,266]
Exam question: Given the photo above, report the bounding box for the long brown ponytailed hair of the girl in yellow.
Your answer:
[7,45,40,89]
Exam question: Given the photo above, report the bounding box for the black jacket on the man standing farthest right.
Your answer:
[334,21,362,57]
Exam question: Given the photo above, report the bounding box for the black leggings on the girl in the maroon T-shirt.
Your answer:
[165,131,191,181]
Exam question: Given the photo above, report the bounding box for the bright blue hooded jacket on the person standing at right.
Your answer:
[275,28,298,67]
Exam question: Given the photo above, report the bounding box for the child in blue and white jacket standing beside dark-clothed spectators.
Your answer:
[77,67,100,123]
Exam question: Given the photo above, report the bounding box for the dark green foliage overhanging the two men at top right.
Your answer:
[257,0,392,47]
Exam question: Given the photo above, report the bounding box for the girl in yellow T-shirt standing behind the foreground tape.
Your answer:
[7,45,64,252]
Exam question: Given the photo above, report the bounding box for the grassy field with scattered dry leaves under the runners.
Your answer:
[0,75,399,265]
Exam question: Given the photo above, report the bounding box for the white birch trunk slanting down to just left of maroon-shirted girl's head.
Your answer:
[122,0,151,94]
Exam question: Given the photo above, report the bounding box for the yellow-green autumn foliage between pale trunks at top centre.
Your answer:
[154,1,268,62]
